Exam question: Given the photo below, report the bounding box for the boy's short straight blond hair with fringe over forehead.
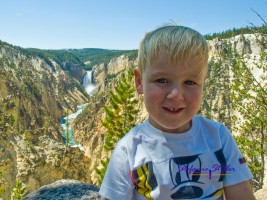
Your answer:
[138,25,208,74]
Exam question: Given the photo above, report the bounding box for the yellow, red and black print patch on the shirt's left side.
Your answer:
[131,161,158,199]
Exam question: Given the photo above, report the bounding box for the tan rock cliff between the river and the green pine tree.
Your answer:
[73,55,147,184]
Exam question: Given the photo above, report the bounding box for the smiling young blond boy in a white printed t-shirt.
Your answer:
[99,25,254,200]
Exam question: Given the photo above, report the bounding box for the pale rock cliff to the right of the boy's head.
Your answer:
[205,33,267,128]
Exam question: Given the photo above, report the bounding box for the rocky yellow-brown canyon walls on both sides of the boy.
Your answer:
[0,29,267,198]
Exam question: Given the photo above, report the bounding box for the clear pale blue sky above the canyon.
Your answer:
[0,0,267,49]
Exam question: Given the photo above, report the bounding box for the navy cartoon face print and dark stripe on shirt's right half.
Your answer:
[169,149,226,199]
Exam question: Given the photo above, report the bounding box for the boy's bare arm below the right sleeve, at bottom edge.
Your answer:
[224,181,256,200]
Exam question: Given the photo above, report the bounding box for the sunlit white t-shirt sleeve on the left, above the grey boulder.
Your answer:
[99,145,134,200]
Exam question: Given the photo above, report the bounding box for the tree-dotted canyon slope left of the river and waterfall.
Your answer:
[0,42,90,199]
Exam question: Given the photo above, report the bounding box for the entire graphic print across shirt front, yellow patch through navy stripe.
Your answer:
[131,149,226,199]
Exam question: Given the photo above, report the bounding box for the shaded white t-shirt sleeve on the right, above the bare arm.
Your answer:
[221,126,253,186]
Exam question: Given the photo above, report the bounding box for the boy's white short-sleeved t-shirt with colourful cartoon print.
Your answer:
[99,116,252,200]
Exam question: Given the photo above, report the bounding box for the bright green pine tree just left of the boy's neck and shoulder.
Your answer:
[96,70,138,184]
